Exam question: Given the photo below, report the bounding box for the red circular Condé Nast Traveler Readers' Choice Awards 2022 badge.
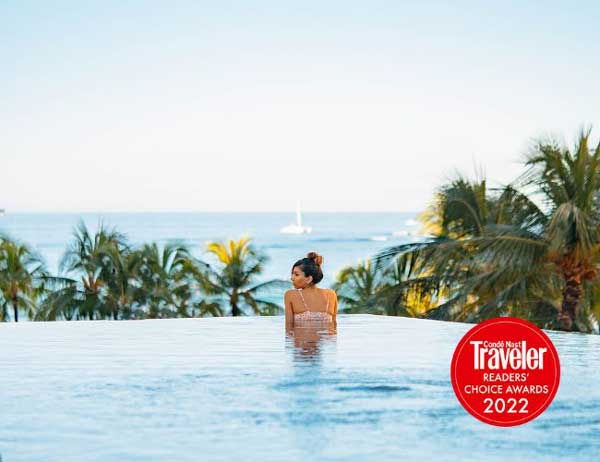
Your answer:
[450,318,560,427]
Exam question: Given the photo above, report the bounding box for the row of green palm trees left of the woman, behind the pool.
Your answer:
[0,223,289,321]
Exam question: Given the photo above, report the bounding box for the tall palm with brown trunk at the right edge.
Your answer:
[512,130,600,331]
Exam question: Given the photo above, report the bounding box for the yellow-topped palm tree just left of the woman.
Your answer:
[199,238,289,316]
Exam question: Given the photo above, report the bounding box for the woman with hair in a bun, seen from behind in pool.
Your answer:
[284,252,338,330]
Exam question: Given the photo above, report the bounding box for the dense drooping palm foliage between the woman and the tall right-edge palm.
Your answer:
[378,179,557,326]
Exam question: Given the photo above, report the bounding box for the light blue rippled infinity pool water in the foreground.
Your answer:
[0,315,600,462]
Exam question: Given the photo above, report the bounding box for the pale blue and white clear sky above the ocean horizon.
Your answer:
[0,0,600,212]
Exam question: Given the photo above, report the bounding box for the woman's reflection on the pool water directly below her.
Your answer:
[286,325,337,362]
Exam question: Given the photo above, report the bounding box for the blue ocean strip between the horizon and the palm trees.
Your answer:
[0,212,419,287]
